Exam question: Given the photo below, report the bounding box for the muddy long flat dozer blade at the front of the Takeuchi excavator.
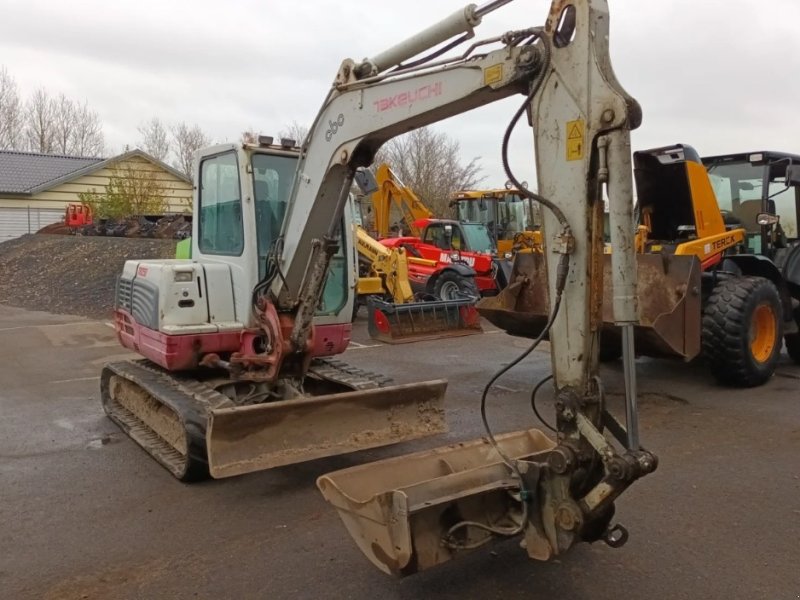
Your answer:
[206,380,447,478]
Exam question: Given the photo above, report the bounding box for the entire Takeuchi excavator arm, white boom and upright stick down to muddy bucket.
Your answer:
[306,0,657,575]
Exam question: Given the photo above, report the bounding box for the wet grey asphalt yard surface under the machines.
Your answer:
[0,306,800,600]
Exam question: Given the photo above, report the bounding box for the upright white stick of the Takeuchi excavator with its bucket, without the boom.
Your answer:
[317,0,657,576]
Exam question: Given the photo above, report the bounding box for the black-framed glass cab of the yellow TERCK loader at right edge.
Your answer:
[703,151,800,258]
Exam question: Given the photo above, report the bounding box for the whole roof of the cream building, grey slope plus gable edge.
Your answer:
[0,149,191,196]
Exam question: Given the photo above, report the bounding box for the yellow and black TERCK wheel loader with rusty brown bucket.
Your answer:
[478,145,800,387]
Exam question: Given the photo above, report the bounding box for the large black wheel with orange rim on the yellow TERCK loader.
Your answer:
[702,277,783,387]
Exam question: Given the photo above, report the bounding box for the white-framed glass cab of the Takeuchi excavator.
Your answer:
[192,141,355,324]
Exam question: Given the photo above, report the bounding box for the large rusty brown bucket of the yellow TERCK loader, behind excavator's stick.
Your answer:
[477,253,702,360]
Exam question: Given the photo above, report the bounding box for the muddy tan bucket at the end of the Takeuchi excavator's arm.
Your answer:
[317,429,555,576]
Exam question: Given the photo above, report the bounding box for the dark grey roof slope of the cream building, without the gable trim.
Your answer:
[0,150,103,194]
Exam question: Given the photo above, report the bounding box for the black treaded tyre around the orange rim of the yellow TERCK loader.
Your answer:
[702,277,780,387]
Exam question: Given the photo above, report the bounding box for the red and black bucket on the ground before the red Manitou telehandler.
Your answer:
[367,297,483,344]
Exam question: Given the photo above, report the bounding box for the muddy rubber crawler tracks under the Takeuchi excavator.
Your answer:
[100,359,391,482]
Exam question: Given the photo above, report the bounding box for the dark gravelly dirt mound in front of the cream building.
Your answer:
[0,234,175,319]
